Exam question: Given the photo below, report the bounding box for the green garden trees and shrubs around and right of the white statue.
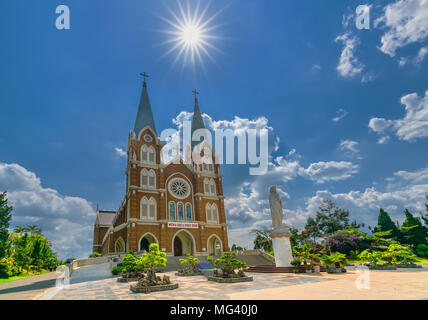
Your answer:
[247,198,428,273]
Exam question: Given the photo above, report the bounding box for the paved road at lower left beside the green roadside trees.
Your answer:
[0,272,58,300]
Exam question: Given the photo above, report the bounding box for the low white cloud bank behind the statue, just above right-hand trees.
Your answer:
[229,167,428,248]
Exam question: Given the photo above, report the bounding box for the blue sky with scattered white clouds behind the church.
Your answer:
[0,0,428,256]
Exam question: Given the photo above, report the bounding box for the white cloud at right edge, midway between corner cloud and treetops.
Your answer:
[369,91,428,143]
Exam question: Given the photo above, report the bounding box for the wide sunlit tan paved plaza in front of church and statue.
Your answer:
[42,266,428,300]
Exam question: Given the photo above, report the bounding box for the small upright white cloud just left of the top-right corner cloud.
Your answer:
[335,32,364,78]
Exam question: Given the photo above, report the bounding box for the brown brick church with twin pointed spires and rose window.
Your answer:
[93,73,229,256]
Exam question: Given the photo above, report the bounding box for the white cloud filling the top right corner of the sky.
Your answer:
[376,0,428,57]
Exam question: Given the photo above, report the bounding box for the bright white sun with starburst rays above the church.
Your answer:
[161,1,222,70]
